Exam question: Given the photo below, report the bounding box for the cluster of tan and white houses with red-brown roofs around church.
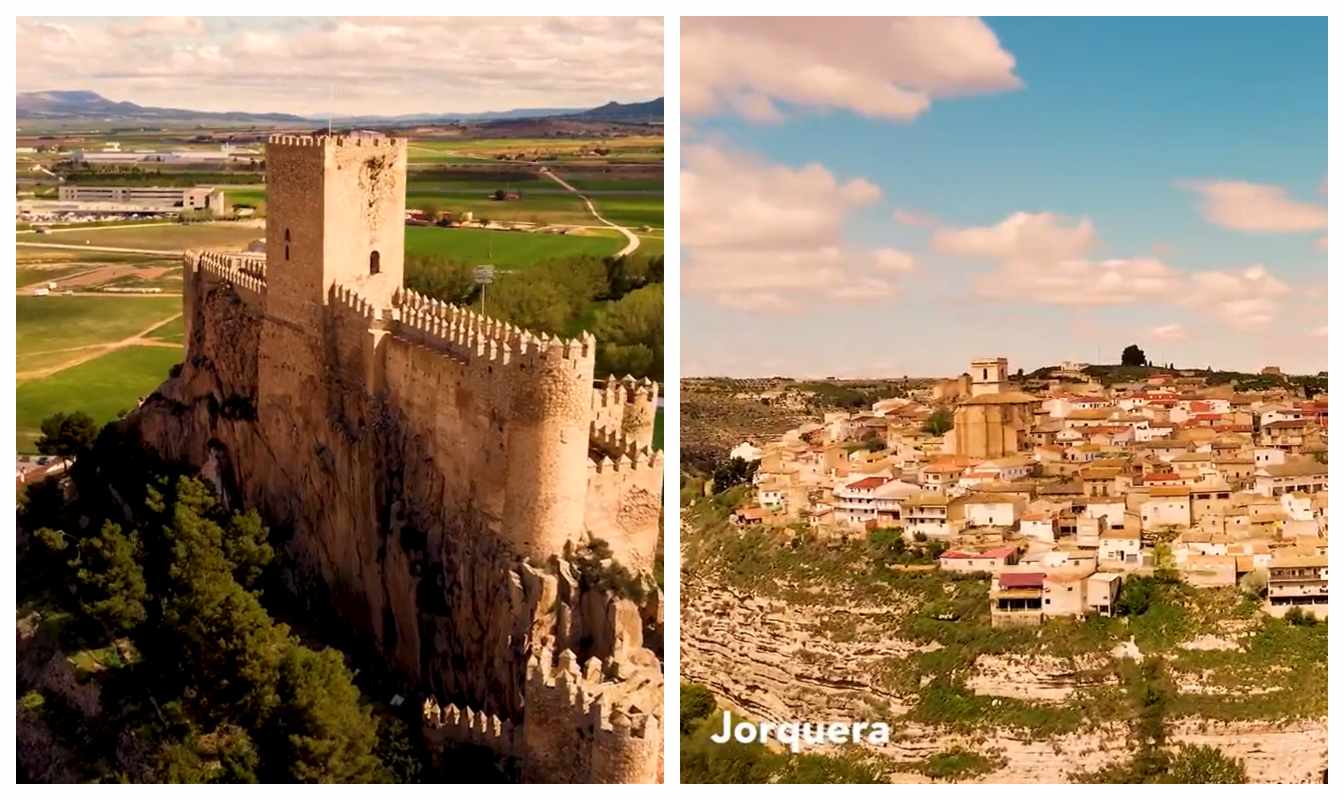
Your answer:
[731,358,1329,624]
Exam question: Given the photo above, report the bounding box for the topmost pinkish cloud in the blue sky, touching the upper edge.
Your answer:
[681,17,1021,121]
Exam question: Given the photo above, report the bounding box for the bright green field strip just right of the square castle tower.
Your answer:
[406,227,625,268]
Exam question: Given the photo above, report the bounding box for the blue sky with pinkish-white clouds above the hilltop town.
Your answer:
[681,19,1327,375]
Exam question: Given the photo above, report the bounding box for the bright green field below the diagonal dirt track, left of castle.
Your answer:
[15,347,181,453]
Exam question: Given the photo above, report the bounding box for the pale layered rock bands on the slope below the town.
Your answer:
[681,578,1327,783]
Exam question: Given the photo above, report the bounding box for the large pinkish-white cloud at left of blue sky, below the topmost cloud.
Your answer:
[681,144,914,312]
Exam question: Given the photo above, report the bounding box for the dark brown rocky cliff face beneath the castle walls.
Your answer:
[124,285,660,718]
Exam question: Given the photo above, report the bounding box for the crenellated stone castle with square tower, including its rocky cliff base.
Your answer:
[136,136,663,783]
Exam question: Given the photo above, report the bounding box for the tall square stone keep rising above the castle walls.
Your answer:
[266,134,406,329]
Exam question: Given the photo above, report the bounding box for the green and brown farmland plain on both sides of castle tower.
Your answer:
[15,124,663,450]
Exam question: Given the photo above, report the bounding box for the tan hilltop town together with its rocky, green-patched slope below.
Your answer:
[683,358,1329,783]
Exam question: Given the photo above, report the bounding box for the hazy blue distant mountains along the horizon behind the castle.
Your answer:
[15,91,663,126]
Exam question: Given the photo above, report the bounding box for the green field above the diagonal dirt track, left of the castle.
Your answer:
[15,297,181,372]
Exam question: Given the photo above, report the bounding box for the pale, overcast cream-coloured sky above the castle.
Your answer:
[17,17,663,114]
